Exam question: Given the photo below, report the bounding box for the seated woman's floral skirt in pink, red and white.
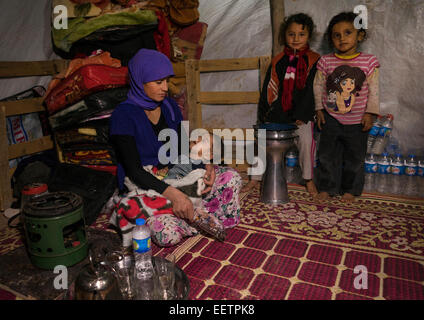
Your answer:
[110,166,242,247]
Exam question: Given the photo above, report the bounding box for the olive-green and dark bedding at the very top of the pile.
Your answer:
[52,0,162,66]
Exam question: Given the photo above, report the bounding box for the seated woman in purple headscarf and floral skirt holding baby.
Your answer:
[110,49,241,246]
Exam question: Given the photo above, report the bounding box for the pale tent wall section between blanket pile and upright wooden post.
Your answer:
[199,0,272,128]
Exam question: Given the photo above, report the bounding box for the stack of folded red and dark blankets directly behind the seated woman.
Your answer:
[44,50,129,174]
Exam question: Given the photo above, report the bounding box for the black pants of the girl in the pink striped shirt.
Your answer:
[317,112,368,196]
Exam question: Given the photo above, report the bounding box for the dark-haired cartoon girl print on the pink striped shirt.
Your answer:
[327,65,366,114]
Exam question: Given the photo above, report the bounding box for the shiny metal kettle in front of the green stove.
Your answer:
[75,251,122,300]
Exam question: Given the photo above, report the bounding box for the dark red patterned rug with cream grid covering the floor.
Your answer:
[0,185,424,300]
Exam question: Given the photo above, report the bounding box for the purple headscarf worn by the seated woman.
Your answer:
[127,49,174,110]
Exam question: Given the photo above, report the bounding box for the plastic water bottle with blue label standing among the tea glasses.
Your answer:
[132,219,154,300]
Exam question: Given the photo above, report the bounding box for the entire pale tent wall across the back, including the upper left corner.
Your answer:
[0,0,424,155]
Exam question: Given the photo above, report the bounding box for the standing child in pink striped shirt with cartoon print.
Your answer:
[314,12,380,202]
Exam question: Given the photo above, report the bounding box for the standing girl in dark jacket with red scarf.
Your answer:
[242,13,320,195]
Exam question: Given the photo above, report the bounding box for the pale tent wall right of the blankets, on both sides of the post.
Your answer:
[199,0,424,156]
